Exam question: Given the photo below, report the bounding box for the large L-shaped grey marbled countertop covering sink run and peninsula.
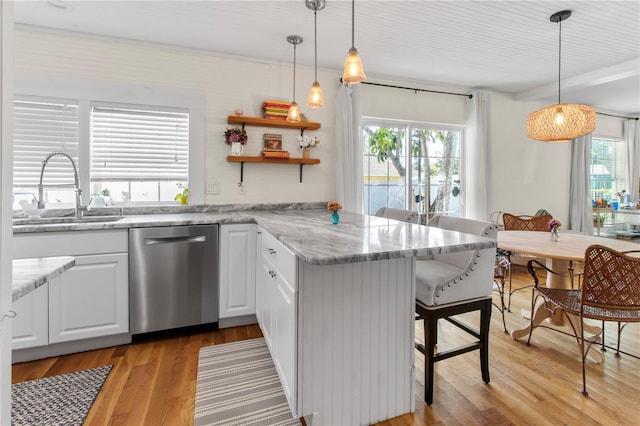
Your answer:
[13,203,496,265]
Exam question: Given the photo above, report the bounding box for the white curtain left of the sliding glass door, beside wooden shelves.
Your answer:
[335,84,363,213]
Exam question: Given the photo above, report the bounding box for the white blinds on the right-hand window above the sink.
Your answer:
[91,105,189,182]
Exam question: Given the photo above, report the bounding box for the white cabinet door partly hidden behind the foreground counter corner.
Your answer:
[11,277,49,349]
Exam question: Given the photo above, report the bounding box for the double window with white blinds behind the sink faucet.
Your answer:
[13,96,189,209]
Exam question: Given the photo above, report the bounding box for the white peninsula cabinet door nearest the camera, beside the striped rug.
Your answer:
[273,275,296,412]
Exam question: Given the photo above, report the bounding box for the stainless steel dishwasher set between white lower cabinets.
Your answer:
[129,225,219,334]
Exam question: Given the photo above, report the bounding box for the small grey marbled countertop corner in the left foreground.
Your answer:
[12,256,76,302]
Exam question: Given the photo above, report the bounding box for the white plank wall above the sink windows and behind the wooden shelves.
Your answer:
[15,29,339,204]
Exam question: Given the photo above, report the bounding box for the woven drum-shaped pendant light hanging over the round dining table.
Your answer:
[527,10,596,142]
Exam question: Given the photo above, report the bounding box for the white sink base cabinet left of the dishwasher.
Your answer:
[13,230,129,349]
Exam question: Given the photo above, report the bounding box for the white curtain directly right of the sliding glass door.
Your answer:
[463,91,491,220]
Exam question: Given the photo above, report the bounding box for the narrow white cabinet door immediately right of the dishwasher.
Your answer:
[220,223,256,318]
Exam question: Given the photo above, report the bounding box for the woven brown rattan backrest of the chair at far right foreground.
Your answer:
[582,244,640,311]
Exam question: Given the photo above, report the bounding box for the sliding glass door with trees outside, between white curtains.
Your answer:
[362,119,462,217]
